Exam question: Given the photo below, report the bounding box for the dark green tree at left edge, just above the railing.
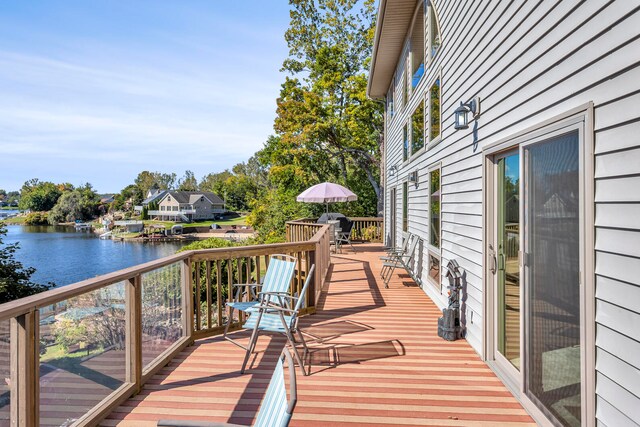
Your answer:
[0,224,55,304]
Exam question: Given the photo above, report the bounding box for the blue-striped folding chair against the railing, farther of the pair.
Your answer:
[223,254,298,350]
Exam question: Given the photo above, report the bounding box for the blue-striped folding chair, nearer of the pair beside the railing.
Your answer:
[240,265,316,375]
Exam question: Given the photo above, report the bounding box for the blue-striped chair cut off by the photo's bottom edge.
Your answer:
[158,348,298,427]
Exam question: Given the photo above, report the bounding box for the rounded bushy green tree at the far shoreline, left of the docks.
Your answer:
[49,183,100,224]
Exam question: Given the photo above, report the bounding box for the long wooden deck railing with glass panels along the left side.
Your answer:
[0,225,330,426]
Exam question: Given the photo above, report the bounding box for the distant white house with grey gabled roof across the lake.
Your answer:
[149,191,225,222]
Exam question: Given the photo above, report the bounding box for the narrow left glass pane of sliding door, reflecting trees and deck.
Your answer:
[497,152,520,370]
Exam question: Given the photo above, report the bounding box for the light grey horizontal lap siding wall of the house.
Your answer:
[384,0,640,426]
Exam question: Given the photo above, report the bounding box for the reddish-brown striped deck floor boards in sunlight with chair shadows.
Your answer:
[103,245,535,426]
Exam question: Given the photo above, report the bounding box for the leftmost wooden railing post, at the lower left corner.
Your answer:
[11,310,40,427]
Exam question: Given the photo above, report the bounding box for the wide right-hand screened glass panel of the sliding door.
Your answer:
[524,131,581,426]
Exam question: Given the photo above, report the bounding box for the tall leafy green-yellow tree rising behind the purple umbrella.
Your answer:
[262,0,383,215]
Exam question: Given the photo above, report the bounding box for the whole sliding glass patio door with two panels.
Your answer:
[488,127,582,426]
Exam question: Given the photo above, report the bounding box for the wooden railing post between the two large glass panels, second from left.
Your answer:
[125,274,143,394]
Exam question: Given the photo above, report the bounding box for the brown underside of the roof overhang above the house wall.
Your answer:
[367,0,416,98]
